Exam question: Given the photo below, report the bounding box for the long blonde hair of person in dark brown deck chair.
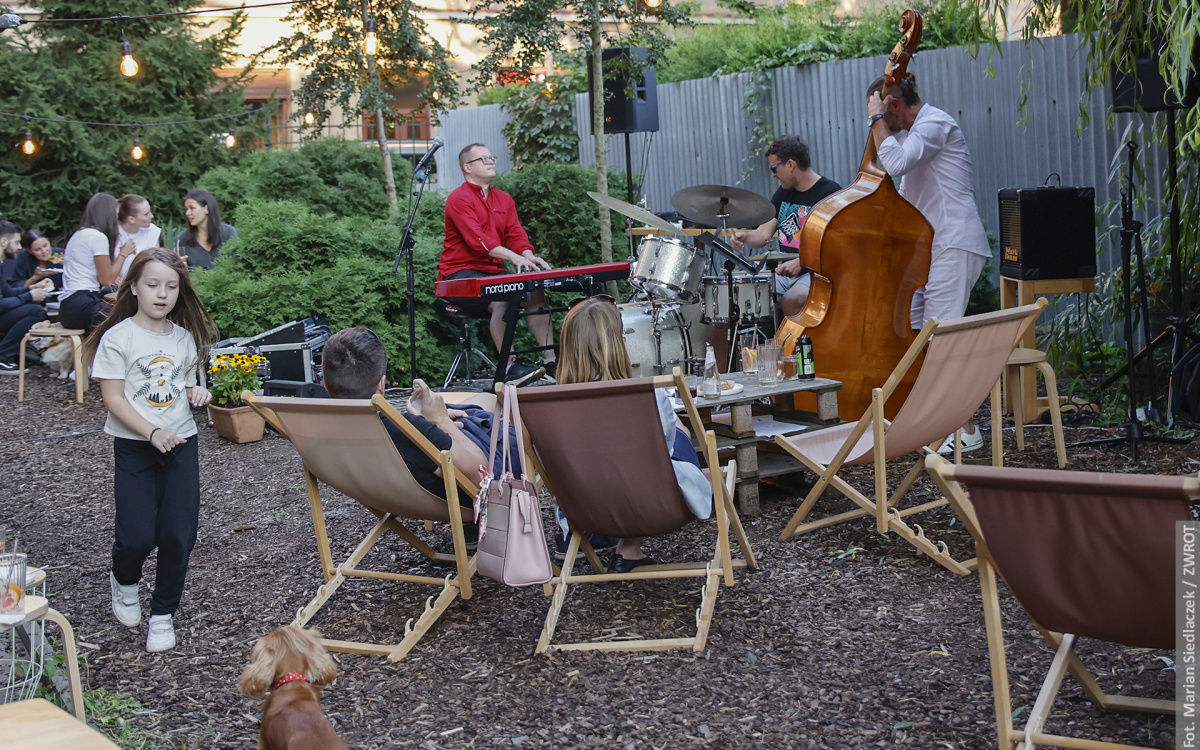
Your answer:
[556,298,634,384]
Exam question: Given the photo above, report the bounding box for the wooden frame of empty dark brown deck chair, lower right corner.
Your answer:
[925,454,1200,750]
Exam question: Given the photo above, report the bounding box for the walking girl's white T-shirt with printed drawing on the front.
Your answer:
[91,318,198,440]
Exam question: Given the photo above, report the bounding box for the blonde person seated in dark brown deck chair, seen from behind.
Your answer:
[557,296,713,572]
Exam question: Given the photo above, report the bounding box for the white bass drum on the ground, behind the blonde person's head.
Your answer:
[618,302,713,378]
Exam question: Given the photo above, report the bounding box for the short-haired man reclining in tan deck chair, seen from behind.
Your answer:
[322,328,487,537]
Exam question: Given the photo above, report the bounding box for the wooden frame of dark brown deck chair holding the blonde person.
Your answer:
[518,367,758,654]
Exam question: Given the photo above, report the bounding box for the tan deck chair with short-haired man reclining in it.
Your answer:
[242,392,494,661]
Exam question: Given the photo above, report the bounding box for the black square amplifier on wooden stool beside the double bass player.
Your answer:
[1000,187,1096,280]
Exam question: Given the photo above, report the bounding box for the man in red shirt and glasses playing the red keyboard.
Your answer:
[438,143,557,380]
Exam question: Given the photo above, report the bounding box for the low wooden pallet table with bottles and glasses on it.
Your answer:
[696,372,841,516]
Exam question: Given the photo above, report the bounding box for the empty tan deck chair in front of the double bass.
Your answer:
[775,298,1046,576]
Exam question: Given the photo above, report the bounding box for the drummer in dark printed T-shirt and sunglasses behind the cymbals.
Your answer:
[733,136,841,296]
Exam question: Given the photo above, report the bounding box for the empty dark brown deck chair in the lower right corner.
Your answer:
[925,455,1200,750]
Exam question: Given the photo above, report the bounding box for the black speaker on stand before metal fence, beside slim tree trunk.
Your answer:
[588,47,659,134]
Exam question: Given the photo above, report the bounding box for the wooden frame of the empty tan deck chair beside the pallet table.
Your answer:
[775,298,1046,576]
